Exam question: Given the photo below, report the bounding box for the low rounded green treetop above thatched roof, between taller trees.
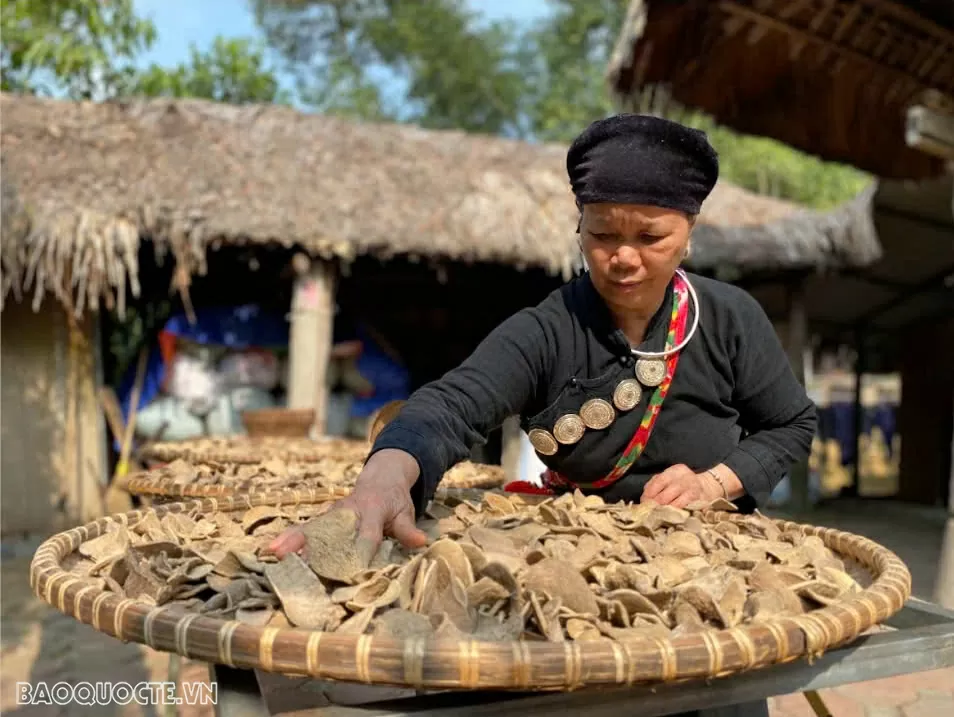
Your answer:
[128,37,290,104]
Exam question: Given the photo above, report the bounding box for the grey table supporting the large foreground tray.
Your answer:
[209,599,954,717]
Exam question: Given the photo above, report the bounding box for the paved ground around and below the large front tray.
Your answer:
[0,503,954,717]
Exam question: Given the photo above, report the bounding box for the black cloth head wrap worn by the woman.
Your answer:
[566,114,719,215]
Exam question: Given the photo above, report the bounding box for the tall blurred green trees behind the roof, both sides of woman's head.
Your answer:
[251,0,869,208]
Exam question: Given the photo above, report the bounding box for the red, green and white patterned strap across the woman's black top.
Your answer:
[504,274,689,495]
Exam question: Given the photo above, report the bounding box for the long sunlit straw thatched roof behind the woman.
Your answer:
[0,95,879,312]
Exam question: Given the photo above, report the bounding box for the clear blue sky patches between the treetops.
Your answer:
[135,0,548,70]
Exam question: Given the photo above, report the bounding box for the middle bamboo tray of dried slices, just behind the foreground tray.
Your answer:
[123,457,506,498]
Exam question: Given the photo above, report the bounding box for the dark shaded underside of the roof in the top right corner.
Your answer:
[608,0,954,179]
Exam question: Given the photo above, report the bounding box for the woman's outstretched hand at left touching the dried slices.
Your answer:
[268,448,427,559]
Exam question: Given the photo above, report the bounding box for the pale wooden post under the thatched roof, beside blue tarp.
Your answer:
[288,255,335,436]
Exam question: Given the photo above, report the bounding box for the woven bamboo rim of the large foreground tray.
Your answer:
[30,491,911,691]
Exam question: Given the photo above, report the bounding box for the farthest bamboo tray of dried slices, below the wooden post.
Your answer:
[139,436,368,465]
